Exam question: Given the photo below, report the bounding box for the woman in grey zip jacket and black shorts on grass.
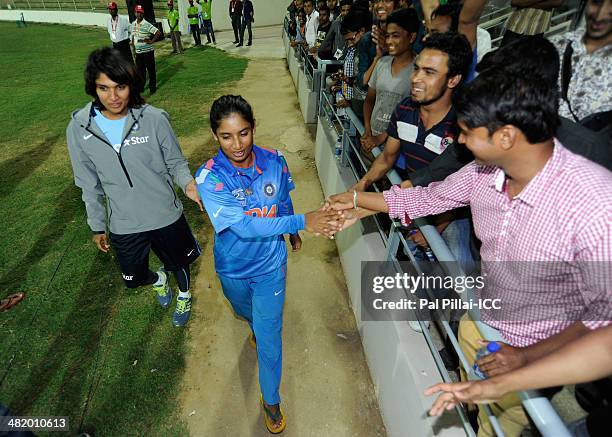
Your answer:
[66,48,202,326]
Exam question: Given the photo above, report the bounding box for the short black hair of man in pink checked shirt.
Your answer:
[454,70,559,144]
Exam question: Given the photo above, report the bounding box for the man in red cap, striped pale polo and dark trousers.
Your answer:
[130,5,161,94]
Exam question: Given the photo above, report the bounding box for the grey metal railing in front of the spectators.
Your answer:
[286,19,571,437]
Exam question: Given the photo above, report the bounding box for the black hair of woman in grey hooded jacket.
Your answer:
[85,47,145,109]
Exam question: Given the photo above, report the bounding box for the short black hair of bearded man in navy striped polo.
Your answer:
[423,32,473,82]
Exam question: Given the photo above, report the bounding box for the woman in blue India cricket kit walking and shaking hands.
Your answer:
[196,96,342,434]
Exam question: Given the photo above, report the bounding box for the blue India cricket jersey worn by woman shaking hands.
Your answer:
[196,145,305,279]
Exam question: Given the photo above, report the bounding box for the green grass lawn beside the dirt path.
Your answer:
[0,22,247,436]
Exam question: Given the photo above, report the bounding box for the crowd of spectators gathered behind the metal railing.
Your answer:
[287,0,612,436]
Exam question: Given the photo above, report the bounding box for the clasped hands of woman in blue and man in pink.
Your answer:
[304,192,360,239]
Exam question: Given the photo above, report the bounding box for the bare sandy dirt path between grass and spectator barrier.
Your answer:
[180,59,385,437]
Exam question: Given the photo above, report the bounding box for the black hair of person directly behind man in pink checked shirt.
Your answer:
[476,35,560,87]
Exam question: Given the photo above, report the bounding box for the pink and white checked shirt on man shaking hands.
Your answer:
[384,140,612,347]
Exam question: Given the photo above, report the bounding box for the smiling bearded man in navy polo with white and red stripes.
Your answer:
[353,34,474,270]
